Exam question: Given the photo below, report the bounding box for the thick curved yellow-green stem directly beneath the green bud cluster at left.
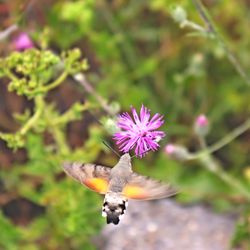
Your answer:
[19,95,44,135]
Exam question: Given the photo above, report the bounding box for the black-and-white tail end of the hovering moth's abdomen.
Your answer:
[102,192,128,225]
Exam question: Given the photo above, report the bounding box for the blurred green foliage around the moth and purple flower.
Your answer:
[0,0,250,250]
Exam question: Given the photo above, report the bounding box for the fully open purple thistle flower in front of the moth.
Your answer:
[113,105,165,157]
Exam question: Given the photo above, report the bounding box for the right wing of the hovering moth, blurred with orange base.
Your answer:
[123,173,177,200]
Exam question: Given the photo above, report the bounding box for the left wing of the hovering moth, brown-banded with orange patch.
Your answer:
[63,162,111,194]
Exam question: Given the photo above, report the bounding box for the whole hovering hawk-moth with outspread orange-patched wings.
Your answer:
[63,153,176,225]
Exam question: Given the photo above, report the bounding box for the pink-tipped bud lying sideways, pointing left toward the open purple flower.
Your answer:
[165,144,191,161]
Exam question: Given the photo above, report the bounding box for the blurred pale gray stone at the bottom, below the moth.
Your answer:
[95,199,235,250]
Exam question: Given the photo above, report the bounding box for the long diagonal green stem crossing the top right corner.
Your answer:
[192,0,250,85]
